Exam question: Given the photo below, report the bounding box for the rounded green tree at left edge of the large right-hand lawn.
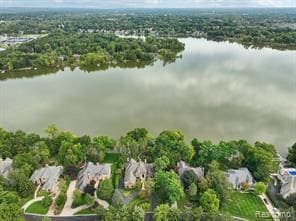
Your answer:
[200,189,219,212]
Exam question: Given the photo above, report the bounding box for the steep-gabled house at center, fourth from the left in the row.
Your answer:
[124,158,153,189]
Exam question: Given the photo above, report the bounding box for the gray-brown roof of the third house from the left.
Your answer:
[77,162,111,191]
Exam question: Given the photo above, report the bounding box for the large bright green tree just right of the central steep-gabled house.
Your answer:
[154,172,184,204]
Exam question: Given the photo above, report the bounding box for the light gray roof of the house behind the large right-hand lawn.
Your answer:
[225,168,254,187]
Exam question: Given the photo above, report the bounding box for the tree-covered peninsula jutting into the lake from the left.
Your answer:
[0,30,184,71]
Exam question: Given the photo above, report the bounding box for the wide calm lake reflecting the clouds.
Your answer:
[0,38,296,154]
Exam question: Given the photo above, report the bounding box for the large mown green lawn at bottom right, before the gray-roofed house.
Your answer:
[222,192,271,221]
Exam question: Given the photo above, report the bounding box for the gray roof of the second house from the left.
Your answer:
[30,166,63,191]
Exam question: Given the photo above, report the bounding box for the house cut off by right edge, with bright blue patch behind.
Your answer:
[277,168,296,198]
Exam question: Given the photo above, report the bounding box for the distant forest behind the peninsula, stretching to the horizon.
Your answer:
[0,8,296,50]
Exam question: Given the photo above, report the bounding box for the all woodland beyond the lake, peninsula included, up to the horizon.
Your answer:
[0,9,296,74]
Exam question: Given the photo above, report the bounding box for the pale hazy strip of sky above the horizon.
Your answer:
[0,0,296,8]
